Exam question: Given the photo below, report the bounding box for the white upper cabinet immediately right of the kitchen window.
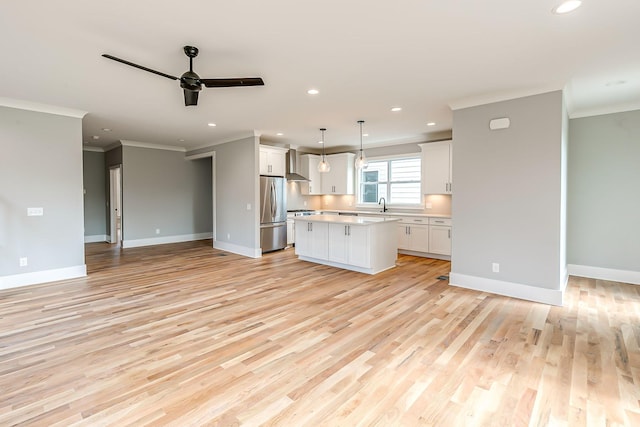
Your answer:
[420,141,452,194]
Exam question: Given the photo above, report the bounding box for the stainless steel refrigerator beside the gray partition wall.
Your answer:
[260,176,287,253]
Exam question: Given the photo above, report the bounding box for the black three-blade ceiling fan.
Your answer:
[102,46,264,106]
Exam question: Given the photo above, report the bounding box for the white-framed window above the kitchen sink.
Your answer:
[358,155,422,206]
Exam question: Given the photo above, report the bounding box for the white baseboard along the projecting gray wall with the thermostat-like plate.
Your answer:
[449,272,567,306]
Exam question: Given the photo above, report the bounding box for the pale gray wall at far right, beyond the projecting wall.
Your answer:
[568,110,640,272]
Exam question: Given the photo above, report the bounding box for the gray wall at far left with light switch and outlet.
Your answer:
[0,107,84,282]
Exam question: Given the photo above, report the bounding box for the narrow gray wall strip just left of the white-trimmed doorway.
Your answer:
[82,150,108,236]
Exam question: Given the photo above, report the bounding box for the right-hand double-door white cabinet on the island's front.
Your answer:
[329,224,371,267]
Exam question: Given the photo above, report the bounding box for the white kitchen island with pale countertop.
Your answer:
[295,215,398,274]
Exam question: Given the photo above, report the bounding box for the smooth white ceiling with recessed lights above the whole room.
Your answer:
[0,0,640,150]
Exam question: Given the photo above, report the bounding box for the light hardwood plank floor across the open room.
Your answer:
[0,241,640,426]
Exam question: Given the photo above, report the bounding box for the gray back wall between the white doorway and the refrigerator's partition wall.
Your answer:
[122,146,213,242]
